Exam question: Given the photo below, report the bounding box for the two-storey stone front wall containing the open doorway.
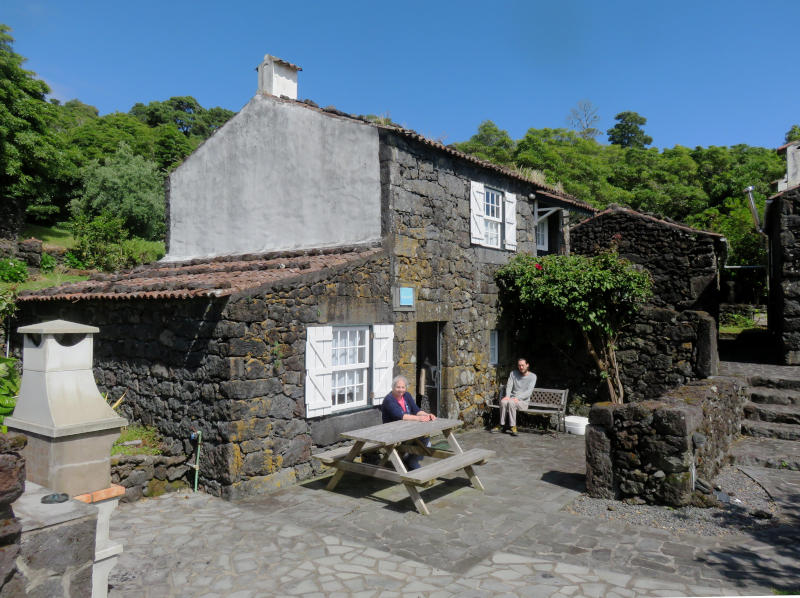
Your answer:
[381,131,580,424]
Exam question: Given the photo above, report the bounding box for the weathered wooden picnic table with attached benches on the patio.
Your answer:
[313,419,494,515]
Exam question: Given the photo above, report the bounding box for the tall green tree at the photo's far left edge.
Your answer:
[0,25,57,238]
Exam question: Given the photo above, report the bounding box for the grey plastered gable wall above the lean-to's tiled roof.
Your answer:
[165,94,381,261]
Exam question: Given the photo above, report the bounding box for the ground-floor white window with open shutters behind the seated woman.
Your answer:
[305,324,394,418]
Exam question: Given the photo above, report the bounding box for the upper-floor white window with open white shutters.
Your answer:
[469,181,517,251]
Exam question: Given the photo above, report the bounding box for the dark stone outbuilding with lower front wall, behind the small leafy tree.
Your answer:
[570,206,727,400]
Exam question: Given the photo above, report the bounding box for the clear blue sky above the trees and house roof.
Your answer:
[6,0,800,148]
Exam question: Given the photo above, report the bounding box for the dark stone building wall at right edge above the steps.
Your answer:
[767,188,800,365]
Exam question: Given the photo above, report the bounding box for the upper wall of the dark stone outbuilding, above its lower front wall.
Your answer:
[570,208,725,317]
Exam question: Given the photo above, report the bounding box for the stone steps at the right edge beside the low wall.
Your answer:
[720,362,800,470]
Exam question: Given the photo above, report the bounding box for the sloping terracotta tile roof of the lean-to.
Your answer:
[18,246,383,302]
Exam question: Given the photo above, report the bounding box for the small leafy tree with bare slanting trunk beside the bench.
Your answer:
[495,251,652,403]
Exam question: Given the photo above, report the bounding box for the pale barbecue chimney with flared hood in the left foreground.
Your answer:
[5,320,128,496]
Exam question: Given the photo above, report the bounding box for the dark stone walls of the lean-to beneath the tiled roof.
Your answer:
[14,254,390,498]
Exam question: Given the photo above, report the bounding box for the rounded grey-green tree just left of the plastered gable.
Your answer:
[71,142,165,240]
